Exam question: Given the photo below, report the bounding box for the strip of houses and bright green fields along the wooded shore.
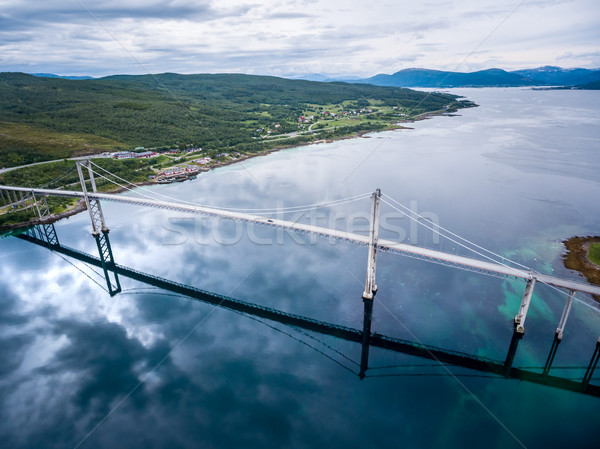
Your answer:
[0,101,448,226]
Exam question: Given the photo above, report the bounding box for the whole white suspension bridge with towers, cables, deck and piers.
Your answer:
[0,160,600,383]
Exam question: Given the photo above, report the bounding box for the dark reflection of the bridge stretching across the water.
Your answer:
[17,225,600,397]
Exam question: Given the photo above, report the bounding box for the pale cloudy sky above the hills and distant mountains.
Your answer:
[0,0,600,77]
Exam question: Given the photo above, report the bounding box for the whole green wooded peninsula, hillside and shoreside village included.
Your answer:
[0,73,476,226]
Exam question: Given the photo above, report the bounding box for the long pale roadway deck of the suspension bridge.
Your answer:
[0,186,600,296]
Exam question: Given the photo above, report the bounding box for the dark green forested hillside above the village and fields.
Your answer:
[0,73,468,167]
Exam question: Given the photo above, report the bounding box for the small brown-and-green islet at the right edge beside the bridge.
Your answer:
[563,236,600,301]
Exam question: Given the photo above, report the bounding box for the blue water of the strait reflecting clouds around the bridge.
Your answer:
[0,89,600,449]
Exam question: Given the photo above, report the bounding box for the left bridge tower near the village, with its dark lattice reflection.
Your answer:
[77,159,121,296]
